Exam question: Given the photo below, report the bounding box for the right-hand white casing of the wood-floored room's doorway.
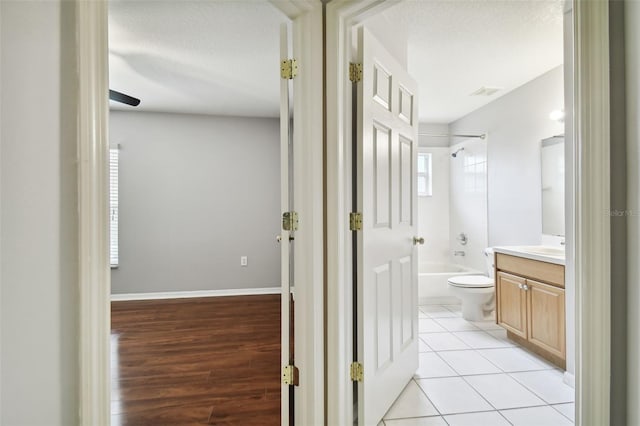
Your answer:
[292,1,325,425]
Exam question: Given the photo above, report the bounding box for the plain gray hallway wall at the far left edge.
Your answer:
[0,1,78,426]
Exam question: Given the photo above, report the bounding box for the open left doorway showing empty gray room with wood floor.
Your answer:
[109,2,291,425]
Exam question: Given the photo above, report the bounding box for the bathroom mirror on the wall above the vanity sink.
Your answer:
[540,135,564,236]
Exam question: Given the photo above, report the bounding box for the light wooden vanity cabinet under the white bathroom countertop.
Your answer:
[495,253,566,368]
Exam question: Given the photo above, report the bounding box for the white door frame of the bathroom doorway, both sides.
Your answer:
[325,0,611,425]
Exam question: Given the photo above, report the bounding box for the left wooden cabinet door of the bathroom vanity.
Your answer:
[496,272,527,339]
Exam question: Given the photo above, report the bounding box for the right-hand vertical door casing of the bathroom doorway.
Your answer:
[574,0,611,425]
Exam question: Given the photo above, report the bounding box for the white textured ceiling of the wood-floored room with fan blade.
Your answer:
[109,0,286,117]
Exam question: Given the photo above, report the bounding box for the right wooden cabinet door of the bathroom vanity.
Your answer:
[527,280,565,359]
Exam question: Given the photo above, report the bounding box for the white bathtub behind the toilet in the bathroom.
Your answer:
[418,263,485,305]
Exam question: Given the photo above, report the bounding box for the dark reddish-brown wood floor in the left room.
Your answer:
[111,295,280,426]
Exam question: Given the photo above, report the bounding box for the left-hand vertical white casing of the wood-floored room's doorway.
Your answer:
[75,0,111,426]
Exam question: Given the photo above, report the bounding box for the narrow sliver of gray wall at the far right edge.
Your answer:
[624,1,640,425]
